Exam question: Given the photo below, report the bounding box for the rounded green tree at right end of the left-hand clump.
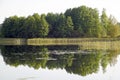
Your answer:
[24,13,49,38]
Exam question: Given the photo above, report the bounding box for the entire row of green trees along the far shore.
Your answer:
[1,6,120,38]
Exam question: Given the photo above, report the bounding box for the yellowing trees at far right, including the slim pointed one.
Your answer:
[101,9,120,37]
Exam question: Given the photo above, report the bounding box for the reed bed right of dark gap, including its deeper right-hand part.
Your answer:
[27,38,120,50]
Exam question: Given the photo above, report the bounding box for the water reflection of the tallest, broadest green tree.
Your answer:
[66,53,101,76]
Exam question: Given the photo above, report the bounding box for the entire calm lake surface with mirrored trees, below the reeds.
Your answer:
[0,46,120,80]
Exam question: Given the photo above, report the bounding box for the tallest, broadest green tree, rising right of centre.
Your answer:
[65,6,100,37]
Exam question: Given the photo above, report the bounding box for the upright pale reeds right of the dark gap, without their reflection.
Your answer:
[27,38,120,45]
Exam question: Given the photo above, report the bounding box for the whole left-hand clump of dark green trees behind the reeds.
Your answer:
[1,13,49,38]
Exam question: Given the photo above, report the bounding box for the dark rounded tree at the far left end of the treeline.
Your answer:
[1,16,19,38]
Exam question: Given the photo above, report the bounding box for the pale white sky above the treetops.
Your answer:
[0,0,120,24]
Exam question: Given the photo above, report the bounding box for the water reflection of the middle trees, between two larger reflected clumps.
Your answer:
[46,54,74,69]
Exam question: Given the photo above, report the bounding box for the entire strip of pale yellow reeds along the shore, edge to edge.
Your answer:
[0,38,120,49]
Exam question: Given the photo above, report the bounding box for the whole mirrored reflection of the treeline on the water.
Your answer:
[2,46,119,76]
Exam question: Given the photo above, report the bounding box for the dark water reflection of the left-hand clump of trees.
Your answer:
[2,46,48,69]
